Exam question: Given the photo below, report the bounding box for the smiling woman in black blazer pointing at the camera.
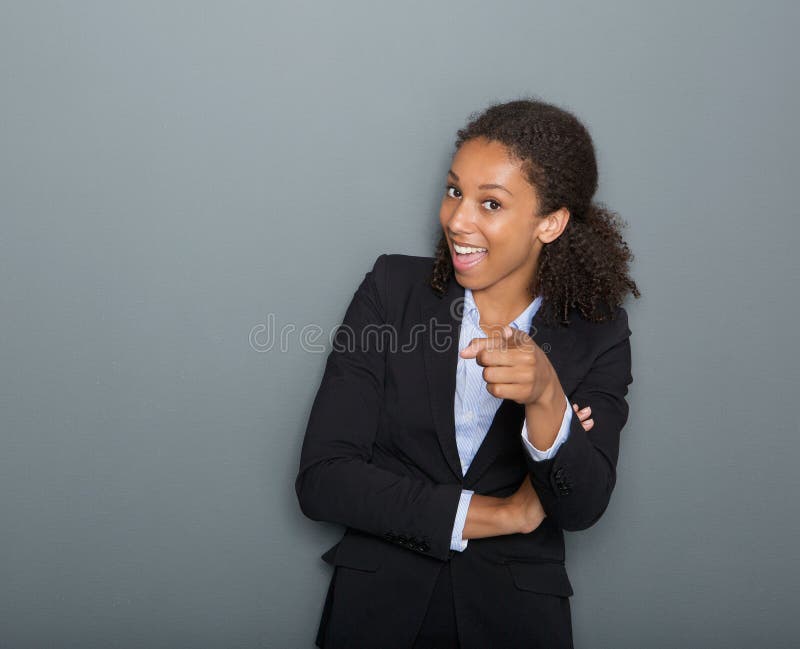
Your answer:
[295,100,639,649]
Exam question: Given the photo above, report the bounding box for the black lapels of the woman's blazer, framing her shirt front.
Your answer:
[420,275,575,484]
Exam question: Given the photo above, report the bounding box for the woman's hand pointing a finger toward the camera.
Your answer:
[459,325,561,405]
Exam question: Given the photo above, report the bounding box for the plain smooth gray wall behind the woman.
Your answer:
[0,0,800,649]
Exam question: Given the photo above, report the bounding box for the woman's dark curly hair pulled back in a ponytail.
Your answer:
[430,99,640,325]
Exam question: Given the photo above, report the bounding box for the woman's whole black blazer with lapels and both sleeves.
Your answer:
[295,254,633,649]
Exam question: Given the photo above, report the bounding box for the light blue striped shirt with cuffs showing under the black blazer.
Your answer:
[450,288,572,552]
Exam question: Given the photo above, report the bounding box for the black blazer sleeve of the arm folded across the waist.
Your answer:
[295,255,461,560]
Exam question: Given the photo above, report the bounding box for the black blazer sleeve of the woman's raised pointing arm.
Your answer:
[524,307,633,531]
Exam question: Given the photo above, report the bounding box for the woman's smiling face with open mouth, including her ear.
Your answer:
[439,138,568,301]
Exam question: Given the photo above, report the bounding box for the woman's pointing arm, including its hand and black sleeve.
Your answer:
[460,307,633,530]
